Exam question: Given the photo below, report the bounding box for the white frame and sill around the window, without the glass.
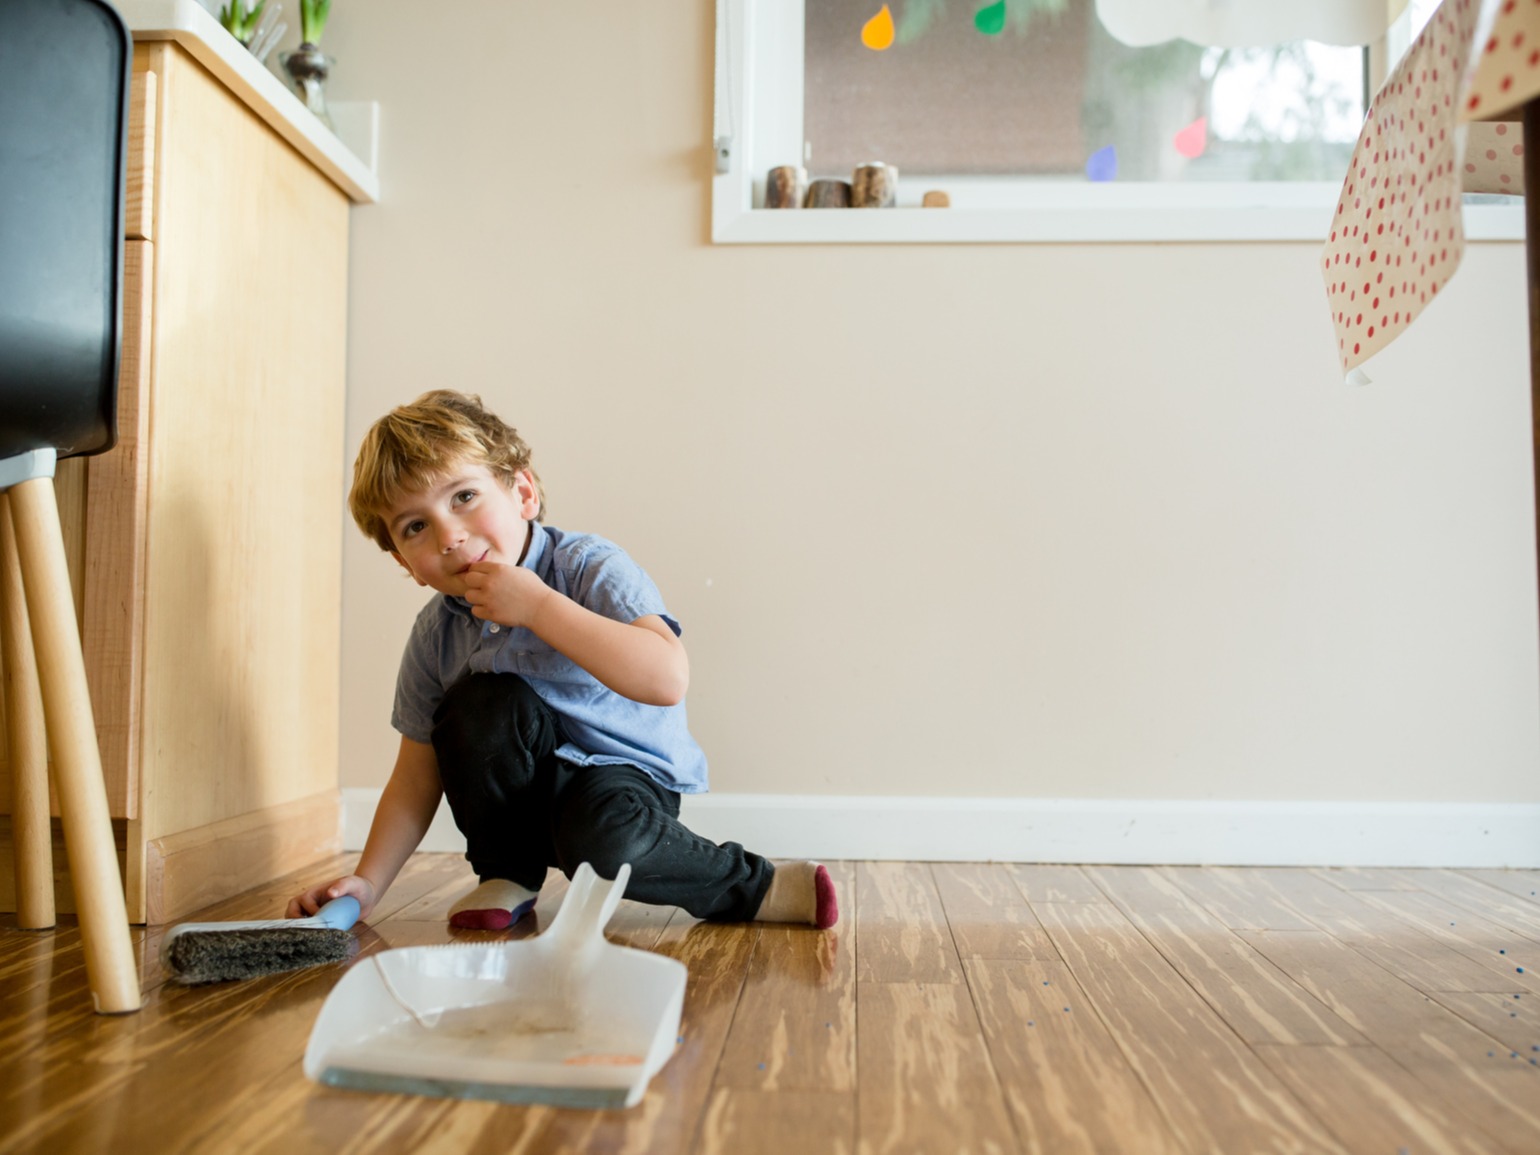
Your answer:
[711,0,1525,245]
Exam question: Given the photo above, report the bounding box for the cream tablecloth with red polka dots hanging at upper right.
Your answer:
[1321,0,1540,371]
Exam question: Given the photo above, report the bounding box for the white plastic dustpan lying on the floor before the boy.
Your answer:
[305,862,688,1107]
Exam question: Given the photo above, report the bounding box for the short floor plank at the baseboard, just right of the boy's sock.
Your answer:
[855,862,963,983]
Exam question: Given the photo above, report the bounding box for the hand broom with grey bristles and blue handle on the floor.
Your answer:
[160,895,359,984]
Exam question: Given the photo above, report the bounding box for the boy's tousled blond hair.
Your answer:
[348,390,545,551]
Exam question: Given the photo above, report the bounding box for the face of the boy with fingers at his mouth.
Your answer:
[385,465,541,598]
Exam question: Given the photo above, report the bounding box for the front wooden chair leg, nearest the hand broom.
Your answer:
[11,477,140,1015]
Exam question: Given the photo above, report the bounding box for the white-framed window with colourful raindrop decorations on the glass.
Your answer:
[713,0,1523,242]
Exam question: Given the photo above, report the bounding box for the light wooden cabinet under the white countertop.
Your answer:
[0,40,350,922]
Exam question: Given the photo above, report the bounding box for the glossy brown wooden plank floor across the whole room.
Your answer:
[0,855,1540,1155]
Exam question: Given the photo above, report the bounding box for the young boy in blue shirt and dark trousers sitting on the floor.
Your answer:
[288,390,838,930]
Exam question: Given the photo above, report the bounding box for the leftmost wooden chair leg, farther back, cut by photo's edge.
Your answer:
[0,493,54,930]
